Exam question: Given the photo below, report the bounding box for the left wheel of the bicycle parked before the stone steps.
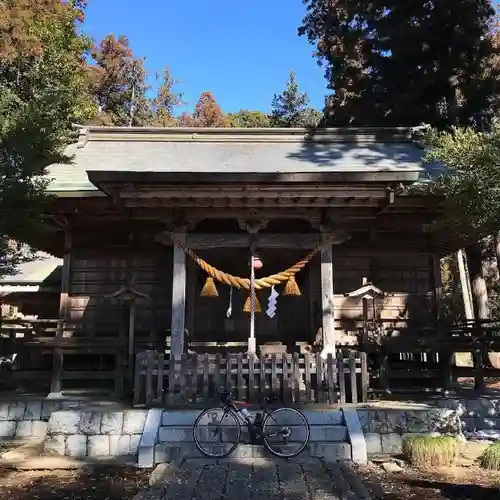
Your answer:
[193,408,241,458]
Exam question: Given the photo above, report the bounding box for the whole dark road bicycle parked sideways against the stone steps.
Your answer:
[193,391,311,458]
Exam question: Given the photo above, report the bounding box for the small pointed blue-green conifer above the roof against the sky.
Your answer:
[271,71,309,127]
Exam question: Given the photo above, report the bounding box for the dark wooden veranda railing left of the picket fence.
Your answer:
[0,318,128,396]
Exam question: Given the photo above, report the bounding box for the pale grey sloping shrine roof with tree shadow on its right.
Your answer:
[47,127,436,194]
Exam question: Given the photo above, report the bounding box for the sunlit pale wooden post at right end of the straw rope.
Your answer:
[321,240,335,357]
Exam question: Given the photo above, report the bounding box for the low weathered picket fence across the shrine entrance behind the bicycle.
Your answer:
[134,350,369,407]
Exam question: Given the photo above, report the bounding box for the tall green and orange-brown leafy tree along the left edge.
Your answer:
[0,0,95,273]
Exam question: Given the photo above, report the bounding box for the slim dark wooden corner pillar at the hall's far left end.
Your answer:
[50,228,71,393]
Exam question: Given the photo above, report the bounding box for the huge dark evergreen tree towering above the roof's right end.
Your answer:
[299,0,498,126]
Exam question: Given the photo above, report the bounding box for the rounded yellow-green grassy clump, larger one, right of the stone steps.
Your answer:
[403,436,459,467]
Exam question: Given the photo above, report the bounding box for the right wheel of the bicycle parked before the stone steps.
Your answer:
[262,408,311,458]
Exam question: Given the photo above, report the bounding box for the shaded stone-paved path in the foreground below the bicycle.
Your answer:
[135,459,370,500]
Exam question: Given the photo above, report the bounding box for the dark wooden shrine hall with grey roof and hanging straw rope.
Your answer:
[3,127,452,402]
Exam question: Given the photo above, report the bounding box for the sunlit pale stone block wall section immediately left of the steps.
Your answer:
[44,409,148,459]
